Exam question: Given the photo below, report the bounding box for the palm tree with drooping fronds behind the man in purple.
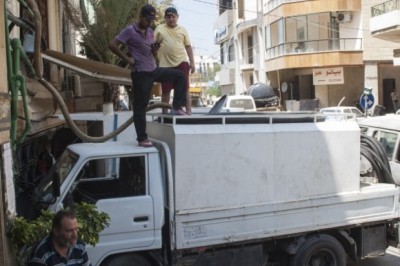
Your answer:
[61,0,172,102]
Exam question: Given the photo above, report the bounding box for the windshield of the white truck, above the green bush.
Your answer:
[37,150,79,204]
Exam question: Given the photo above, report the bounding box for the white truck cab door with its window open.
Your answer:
[64,155,155,254]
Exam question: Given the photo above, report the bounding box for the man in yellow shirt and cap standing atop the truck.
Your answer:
[154,7,195,115]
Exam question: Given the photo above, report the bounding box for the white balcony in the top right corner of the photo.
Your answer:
[370,0,400,42]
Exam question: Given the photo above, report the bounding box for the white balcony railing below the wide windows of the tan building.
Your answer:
[266,38,362,59]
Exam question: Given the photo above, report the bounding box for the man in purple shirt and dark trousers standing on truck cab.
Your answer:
[108,5,186,147]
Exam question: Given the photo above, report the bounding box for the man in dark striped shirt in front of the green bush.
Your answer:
[27,210,92,266]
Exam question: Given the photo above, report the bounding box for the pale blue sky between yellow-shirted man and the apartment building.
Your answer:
[169,0,219,57]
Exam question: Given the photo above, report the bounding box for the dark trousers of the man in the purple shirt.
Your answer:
[131,67,186,141]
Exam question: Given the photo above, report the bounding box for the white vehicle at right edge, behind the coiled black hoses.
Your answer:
[358,114,400,185]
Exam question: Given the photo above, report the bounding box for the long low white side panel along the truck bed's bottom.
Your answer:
[175,184,399,249]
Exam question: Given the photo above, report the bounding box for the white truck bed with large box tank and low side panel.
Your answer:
[148,113,399,249]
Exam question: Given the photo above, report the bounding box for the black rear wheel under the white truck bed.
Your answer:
[291,235,346,266]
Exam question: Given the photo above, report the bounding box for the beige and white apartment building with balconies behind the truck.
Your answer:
[215,0,400,111]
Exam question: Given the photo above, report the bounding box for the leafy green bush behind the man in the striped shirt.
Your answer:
[8,202,110,265]
